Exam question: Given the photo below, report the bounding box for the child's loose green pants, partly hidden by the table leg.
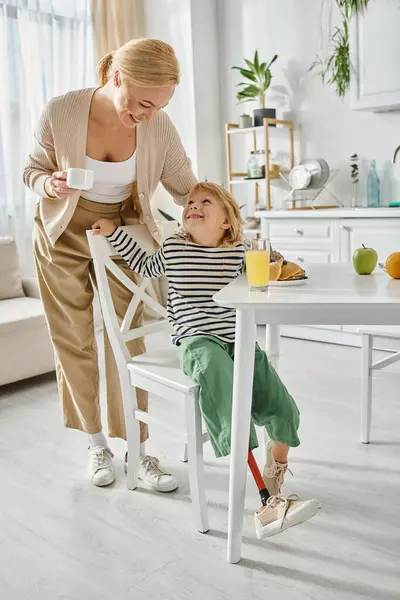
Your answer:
[179,336,300,456]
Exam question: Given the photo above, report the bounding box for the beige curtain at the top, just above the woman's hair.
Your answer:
[92,0,144,60]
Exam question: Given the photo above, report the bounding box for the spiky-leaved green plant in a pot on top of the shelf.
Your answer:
[232,50,278,127]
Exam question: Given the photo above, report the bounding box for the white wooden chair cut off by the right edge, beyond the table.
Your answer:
[359,327,400,444]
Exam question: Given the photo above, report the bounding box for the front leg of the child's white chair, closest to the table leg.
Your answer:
[185,396,210,533]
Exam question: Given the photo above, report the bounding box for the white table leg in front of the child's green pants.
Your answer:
[227,310,256,563]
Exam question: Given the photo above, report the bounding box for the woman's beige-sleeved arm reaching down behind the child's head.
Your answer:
[161,113,197,206]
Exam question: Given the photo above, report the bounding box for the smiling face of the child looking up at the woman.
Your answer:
[183,189,229,246]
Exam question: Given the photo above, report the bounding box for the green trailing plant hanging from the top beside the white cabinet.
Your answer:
[310,0,370,98]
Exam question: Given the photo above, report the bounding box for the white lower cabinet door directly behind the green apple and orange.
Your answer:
[340,218,400,263]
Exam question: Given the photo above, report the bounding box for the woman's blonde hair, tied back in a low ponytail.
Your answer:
[97,38,179,87]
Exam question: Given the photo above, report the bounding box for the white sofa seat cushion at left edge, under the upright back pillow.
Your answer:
[0,297,46,336]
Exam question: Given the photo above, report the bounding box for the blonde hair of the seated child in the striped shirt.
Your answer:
[188,181,243,247]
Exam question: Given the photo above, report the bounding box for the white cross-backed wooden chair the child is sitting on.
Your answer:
[87,223,209,533]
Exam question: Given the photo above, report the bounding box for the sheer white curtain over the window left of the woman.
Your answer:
[0,0,95,275]
